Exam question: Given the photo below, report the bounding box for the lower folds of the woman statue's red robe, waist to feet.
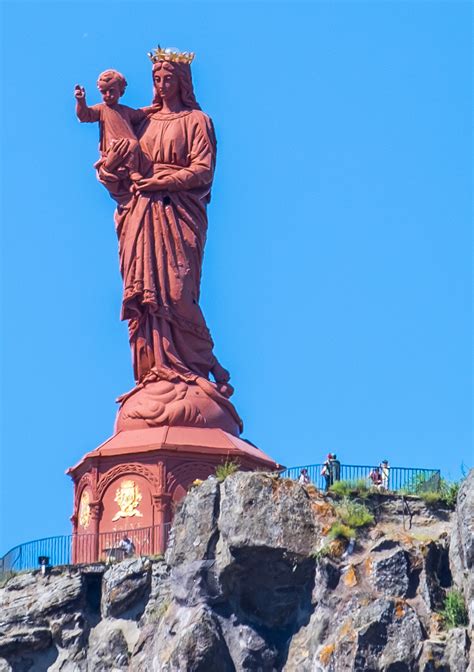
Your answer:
[116,186,215,381]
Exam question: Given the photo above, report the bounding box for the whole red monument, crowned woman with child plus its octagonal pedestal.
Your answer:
[67,49,280,562]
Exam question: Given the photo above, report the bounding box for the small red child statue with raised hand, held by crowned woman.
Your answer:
[74,70,156,182]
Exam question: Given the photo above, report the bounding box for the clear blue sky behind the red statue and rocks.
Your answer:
[0,1,473,554]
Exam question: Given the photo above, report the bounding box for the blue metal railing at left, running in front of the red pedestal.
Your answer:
[0,523,171,574]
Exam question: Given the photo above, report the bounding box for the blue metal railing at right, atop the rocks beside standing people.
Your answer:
[281,464,441,494]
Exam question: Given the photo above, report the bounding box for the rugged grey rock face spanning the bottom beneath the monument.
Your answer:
[0,472,474,672]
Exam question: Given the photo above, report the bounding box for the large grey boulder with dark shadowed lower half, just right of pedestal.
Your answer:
[214,472,318,629]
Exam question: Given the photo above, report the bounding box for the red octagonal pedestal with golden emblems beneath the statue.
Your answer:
[67,426,281,562]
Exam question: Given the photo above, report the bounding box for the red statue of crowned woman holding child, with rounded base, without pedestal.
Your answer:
[75,49,241,435]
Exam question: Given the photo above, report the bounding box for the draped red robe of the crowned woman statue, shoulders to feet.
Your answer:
[99,110,216,382]
